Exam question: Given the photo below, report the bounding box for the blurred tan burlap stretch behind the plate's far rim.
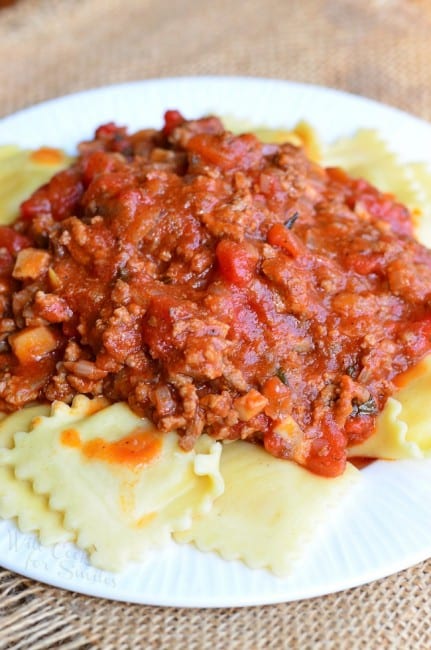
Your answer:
[0,0,431,119]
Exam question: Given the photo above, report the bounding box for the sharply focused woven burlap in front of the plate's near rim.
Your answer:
[0,562,431,650]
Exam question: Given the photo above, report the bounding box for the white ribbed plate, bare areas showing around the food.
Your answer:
[0,77,431,607]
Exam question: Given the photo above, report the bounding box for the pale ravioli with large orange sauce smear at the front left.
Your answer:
[0,396,223,570]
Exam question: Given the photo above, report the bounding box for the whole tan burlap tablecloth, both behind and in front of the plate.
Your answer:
[0,0,431,650]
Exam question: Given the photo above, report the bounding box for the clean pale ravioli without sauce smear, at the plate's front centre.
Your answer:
[175,441,359,575]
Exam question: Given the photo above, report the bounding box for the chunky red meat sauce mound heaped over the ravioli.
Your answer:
[0,111,431,476]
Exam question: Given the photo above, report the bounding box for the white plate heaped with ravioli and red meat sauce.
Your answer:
[0,77,431,607]
